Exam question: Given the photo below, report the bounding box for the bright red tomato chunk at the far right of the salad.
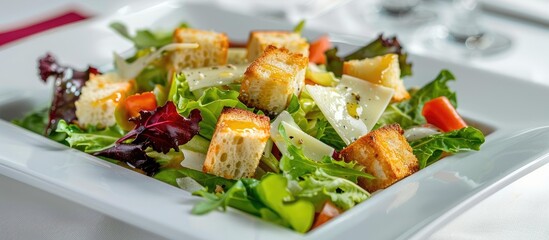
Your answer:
[421,96,467,132]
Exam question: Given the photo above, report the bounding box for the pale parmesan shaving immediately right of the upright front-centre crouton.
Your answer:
[271,111,334,161]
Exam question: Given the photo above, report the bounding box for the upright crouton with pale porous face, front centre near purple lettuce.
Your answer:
[202,108,271,179]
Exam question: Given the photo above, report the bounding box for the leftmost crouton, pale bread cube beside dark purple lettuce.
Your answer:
[74,73,135,128]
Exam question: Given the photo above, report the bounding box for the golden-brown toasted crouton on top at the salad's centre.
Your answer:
[239,46,308,115]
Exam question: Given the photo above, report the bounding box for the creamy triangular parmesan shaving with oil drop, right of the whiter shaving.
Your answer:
[338,75,395,130]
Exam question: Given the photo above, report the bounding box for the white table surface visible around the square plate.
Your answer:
[0,0,549,239]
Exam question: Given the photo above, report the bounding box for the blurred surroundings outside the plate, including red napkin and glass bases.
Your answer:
[0,0,549,239]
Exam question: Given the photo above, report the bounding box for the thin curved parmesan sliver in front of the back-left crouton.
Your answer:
[114,43,198,80]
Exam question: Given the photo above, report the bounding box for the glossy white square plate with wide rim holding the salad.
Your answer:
[0,2,549,239]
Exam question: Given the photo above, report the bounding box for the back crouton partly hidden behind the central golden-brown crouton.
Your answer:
[246,31,309,62]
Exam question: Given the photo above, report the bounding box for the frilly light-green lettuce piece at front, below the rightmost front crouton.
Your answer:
[298,169,370,210]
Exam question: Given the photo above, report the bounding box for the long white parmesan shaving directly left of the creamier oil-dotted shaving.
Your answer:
[306,85,368,145]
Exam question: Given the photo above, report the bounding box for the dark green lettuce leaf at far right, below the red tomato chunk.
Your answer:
[410,127,484,169]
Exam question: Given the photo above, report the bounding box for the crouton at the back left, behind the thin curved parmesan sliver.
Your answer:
[170,28,229,72]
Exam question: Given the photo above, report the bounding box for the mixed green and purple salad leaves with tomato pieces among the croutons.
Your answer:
[13,23,484,233]
